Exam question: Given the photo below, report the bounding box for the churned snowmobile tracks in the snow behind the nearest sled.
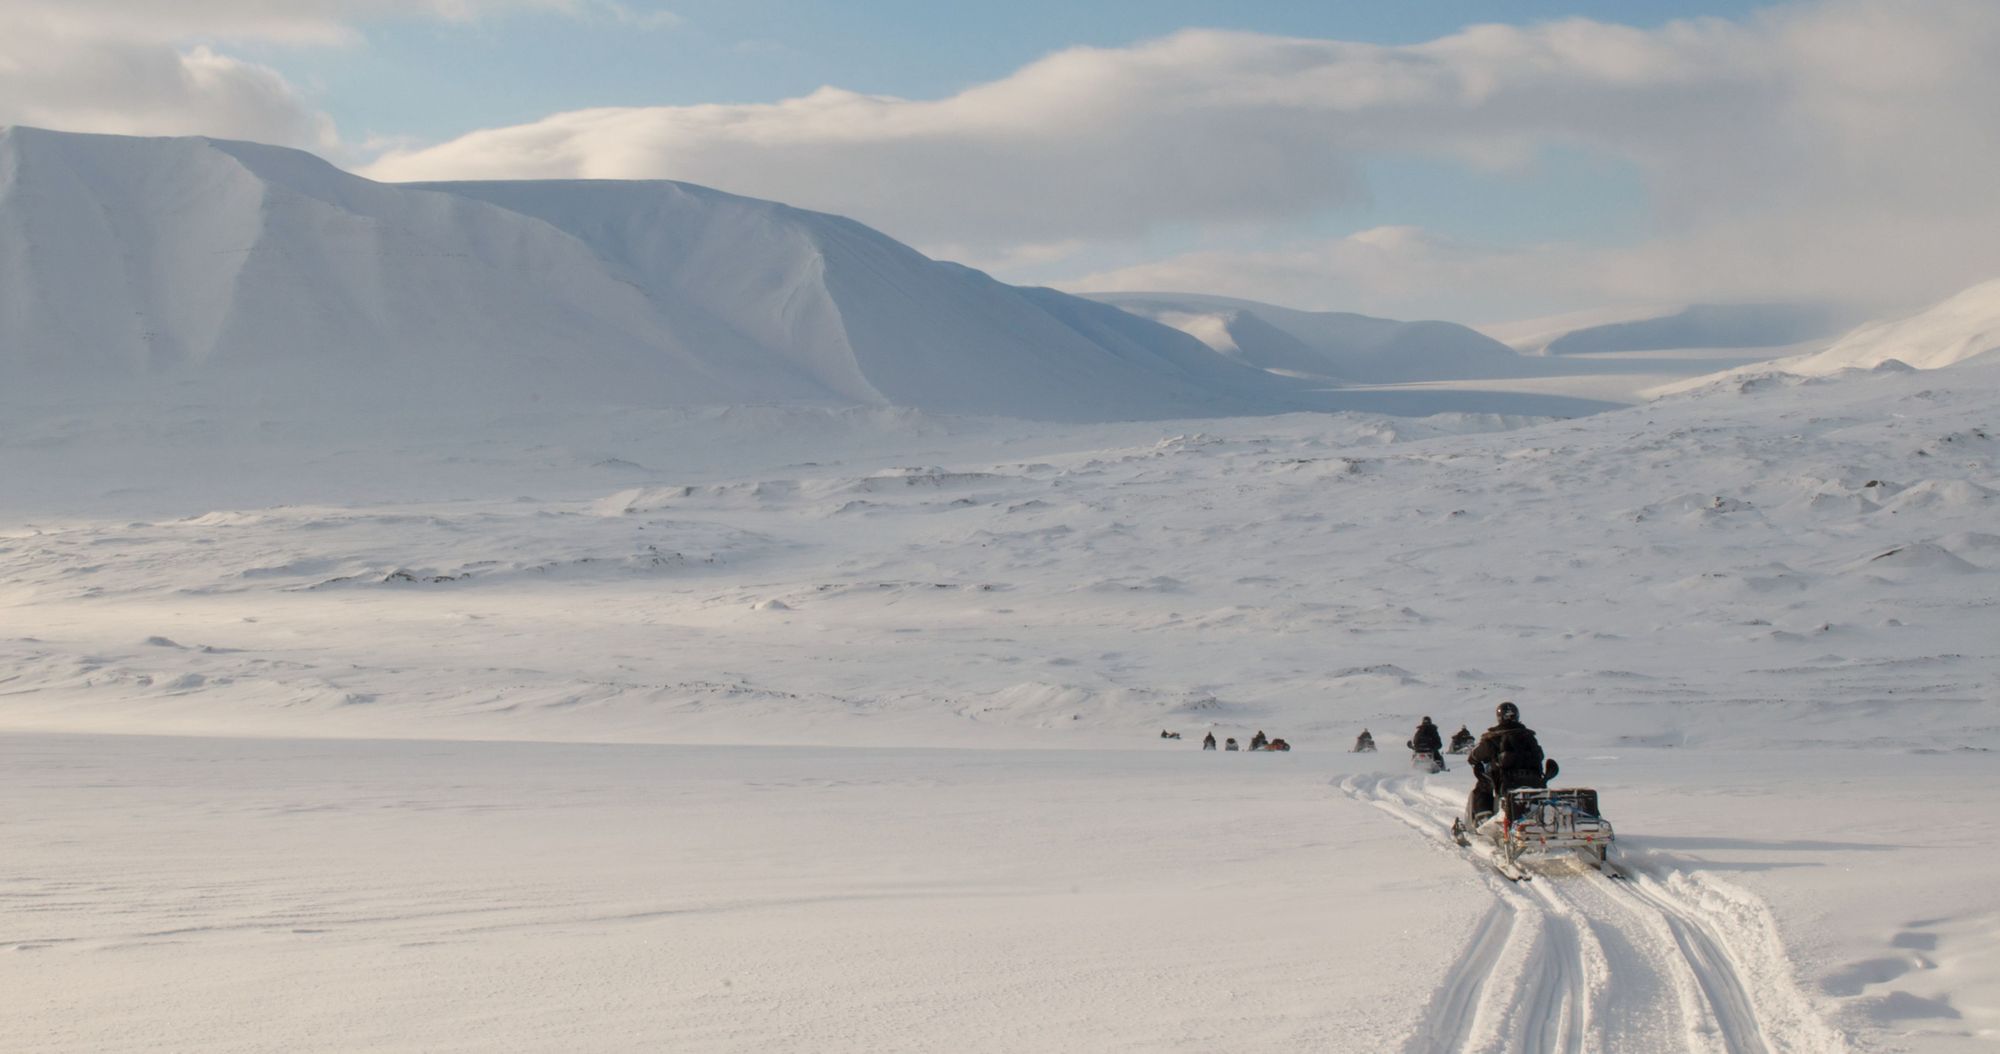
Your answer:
[1340,776,1848,1054]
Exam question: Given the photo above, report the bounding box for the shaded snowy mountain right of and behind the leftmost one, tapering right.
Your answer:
[410,180,1300,420]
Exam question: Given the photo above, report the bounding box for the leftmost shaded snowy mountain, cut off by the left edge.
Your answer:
[0,128,776,404]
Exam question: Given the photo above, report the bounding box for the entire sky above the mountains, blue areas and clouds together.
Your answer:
[0,0,2000,320]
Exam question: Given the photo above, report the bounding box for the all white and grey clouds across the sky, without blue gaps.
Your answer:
[0,0,2000,318]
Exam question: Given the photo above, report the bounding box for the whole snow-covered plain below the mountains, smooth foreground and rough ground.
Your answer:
[0,278,2000,1054]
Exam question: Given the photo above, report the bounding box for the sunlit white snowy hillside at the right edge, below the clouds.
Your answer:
[1656,278,2000,394]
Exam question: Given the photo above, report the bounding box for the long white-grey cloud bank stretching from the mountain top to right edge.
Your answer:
[368,0,2000,318]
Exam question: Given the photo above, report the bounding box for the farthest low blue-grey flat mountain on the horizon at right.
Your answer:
[1480,304,1854,356]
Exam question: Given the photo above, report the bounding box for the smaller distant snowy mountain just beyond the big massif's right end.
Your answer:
[1090,292,1526,384]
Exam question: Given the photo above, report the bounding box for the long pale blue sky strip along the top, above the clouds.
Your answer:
[278,0,1768,140]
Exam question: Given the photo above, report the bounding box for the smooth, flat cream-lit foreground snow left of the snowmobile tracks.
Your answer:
[11,736,1466,1052]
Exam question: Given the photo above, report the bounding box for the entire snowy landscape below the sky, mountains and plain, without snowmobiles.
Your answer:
[0,128,2000,1054]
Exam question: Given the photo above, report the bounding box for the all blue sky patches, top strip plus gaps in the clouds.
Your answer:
[242,0,1758,308]
